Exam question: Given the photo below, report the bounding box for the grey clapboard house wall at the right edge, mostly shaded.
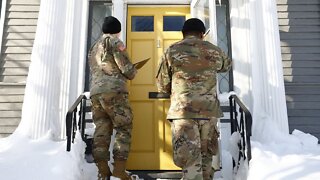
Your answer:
[277,0,320,138]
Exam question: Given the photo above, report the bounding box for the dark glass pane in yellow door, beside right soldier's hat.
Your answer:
[163,16,186,31]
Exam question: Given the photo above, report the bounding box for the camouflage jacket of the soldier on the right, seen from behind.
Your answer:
[157,36,231,119]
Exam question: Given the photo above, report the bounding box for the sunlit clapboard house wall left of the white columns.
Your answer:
[0,0,40,137]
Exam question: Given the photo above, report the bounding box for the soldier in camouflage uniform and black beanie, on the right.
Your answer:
[157,18,231,180]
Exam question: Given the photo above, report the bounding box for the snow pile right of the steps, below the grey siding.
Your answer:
[248,130,320,180]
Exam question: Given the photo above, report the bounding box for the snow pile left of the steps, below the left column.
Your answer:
[0,133,85,180]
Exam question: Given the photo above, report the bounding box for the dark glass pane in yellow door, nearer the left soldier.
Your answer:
[131,16,154,32]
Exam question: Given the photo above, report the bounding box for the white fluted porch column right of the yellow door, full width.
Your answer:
[230,0,289,138]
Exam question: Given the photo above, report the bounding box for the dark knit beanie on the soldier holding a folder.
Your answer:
[102,16,121,34]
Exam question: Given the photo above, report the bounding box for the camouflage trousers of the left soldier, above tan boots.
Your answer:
[91,93,133,163]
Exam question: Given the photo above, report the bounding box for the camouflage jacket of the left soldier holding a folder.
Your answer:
[88,34,137,96]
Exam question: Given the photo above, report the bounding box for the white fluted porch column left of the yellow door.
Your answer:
[15,0,87,140]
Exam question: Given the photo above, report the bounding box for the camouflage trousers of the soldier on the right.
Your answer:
[171,118,219,180]
